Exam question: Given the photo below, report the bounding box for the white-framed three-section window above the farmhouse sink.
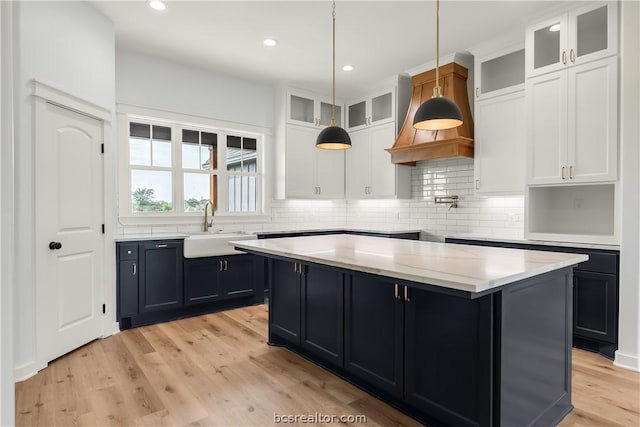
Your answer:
[121,112,263,216]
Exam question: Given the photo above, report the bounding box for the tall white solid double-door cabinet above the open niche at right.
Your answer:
[526,57,618,185]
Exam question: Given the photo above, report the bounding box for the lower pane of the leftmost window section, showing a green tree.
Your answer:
[131,169,173,212]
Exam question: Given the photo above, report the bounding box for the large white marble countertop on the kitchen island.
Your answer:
[231,234,589,293]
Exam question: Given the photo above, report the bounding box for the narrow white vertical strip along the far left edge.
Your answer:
[0,2,15,426]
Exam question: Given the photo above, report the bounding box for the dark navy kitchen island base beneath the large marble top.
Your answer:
[268,259,573,427]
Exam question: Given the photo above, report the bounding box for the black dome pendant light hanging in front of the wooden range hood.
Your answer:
[413,0,462,130]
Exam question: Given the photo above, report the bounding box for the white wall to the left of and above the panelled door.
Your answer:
[14,2,115,380]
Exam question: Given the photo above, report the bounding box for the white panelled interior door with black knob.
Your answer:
[35,100,104,363]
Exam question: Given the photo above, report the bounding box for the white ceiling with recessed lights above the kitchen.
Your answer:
[91,0,572,98]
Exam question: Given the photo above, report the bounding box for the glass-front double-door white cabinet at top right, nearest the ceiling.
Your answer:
[526,2,618,77]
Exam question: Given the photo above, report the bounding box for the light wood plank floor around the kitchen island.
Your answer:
[16,305,640,427]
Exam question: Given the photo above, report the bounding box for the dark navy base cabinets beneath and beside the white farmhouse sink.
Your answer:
[117,240,264,330]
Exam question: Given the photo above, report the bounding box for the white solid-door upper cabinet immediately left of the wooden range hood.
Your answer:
[345,123,411,199]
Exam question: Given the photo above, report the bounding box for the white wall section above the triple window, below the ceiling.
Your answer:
[116,49,274,128]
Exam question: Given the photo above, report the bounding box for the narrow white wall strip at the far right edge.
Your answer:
[615,0,640,371]
